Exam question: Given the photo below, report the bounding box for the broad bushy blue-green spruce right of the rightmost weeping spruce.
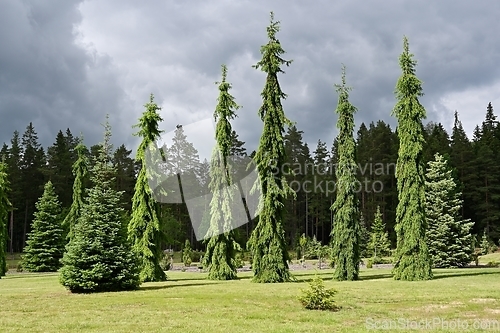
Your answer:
[425,153,474,268]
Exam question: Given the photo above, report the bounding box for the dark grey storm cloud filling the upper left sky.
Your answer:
[0,0,131,146]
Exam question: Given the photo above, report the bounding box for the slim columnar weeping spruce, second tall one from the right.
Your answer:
[331,66,361,281]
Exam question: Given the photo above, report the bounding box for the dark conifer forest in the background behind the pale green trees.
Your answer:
[0,103,500,252]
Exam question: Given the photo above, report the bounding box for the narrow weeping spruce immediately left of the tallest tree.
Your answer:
[203,65,241,280]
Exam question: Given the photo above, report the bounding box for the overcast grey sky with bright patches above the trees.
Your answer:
[0,0,500,158]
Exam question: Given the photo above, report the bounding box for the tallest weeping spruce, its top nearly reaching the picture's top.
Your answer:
[248,12,294,283]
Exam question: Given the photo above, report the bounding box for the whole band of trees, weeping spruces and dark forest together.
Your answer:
[0,14,500,291]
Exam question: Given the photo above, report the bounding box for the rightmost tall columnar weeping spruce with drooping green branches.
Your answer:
[393,37,432,281]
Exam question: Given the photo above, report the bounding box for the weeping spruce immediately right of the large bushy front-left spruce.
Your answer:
[128,94,167,282]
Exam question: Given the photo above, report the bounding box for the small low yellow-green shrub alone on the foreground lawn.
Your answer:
[298,275,340,311]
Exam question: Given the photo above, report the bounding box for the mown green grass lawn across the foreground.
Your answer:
[0,268,500,333]
